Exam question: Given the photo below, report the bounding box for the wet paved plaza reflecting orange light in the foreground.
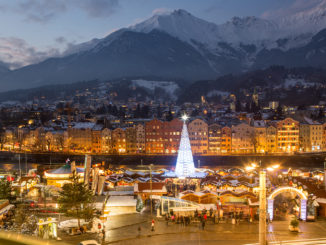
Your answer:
[55,214,326,245]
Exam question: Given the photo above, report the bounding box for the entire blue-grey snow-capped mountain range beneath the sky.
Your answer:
[0,4,326,93]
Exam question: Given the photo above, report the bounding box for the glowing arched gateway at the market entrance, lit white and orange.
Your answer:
[267,186,307,221]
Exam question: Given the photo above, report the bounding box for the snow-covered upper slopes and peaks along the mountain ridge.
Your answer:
[56,0,326,58]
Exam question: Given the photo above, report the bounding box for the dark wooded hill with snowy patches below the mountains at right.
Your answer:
[178,66,326,105]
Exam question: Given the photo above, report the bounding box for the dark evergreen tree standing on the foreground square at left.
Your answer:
[58,171,93,227]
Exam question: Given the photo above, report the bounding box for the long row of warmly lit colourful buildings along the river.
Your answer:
[1,118,326,155]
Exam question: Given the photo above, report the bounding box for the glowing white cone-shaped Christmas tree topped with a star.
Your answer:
[175,115,195,177]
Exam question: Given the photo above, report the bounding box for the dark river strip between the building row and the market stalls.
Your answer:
[0,152,326,168]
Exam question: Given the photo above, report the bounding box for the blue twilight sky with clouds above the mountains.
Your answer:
[0,0,321,68]
